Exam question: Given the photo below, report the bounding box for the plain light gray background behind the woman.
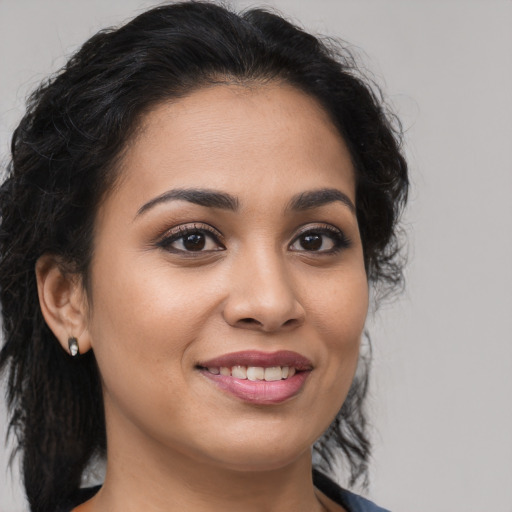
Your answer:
[0,0,512,512]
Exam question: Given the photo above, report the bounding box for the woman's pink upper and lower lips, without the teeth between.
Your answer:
[198,350,313,405]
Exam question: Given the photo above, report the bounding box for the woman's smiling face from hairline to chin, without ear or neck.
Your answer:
[85,84,368,470]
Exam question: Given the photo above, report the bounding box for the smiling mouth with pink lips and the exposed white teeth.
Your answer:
[196,351,313,405]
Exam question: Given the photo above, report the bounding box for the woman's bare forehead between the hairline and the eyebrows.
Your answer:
[108,84,355,212]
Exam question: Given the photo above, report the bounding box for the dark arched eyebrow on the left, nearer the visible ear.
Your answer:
[136,188,239,217]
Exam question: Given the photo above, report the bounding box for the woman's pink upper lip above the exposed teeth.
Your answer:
[198,350,313,370]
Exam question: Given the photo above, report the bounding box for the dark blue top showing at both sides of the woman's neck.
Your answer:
[56,470,389,512]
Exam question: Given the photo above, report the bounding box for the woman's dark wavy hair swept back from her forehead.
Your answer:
[0,1,408,512]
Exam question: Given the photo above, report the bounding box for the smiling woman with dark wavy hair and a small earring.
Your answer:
[0,2,408,512]
